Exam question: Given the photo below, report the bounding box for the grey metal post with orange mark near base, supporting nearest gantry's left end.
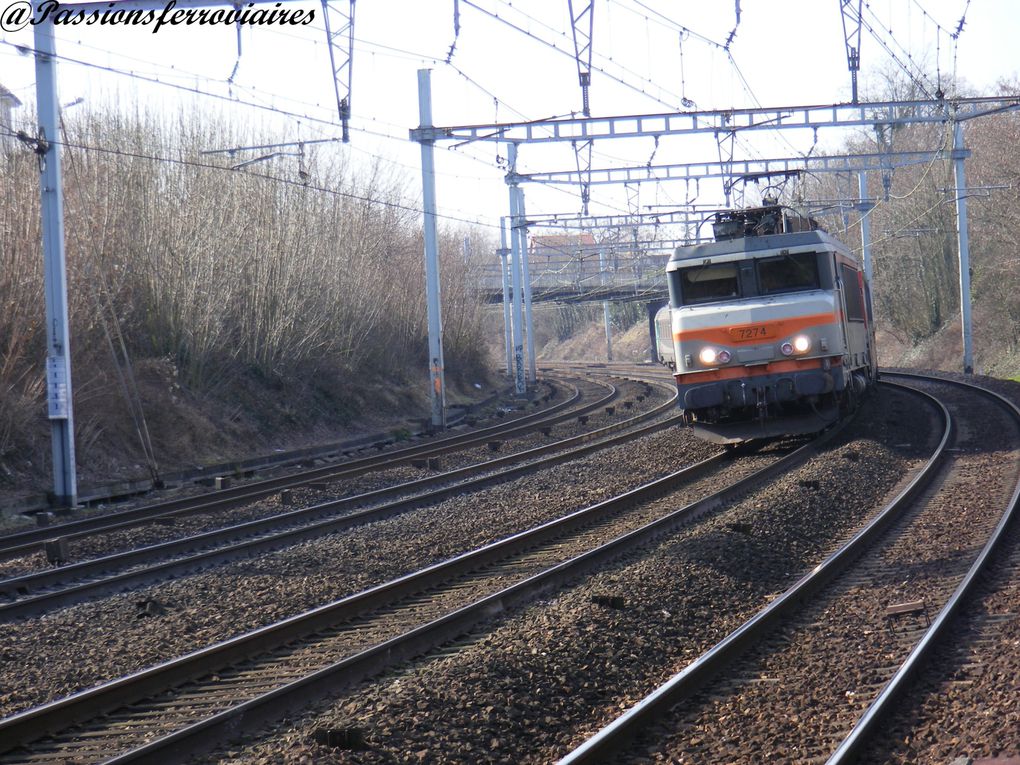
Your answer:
[418,69,446,429]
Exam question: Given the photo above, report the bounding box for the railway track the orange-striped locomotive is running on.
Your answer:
[0,391,840,763]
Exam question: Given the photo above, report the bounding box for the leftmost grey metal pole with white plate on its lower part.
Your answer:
[35,17,78,507]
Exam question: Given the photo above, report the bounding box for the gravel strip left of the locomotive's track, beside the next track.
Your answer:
[0,401,715,716]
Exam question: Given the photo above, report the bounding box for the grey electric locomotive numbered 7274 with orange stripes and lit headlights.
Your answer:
[656,205,878,444]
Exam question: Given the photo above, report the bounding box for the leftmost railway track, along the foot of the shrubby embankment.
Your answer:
[0,384,583,560]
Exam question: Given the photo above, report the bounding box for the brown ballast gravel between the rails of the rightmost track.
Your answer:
[620,375,1020,765]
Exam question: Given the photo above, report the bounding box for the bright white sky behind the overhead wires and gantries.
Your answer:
[0,0,1020,233]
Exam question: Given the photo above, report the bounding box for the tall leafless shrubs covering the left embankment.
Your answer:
[0,99,491,477]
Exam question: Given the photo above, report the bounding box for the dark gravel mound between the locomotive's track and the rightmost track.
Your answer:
[207,391,932,765]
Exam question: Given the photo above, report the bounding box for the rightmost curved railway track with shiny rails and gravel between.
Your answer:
[560,374,1020,765]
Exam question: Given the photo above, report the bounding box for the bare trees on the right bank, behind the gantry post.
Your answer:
[799,78,1020,368]
